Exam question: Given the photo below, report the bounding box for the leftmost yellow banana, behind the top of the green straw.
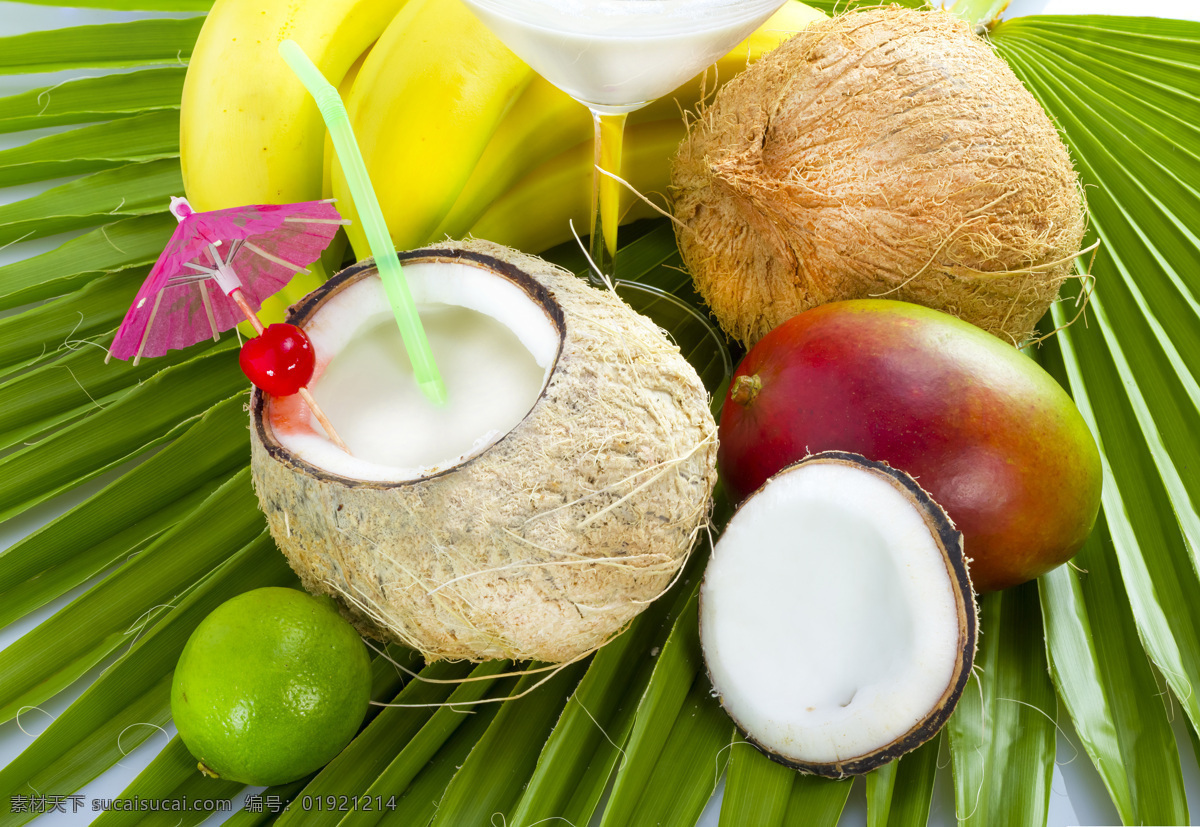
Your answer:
[180,0,404,210]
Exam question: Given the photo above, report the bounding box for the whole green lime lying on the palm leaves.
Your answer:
[170,588,371,786]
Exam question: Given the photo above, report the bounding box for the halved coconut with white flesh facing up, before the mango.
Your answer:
[700,453,977,778]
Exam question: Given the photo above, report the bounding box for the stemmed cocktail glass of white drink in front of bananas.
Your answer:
[464,0,784,386]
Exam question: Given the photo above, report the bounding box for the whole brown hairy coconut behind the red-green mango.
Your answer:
[672,6,1086,344]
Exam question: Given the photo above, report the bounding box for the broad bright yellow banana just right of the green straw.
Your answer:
[332,0,533,258]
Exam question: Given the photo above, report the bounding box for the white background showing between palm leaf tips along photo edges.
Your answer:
[0,0,1200,827]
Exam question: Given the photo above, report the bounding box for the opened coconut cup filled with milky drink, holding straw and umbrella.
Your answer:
[251,241,716,661]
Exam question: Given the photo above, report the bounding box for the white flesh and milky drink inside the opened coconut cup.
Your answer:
[269,262,559,481]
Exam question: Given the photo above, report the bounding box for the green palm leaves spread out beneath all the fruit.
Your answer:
[0,6,1200,827]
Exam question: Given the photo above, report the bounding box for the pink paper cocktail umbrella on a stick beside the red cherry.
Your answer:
[106,198,349,449]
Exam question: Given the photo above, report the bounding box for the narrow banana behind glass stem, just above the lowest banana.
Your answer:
[436,0,826,238]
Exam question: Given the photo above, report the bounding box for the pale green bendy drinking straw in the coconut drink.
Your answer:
[280,40,446,404]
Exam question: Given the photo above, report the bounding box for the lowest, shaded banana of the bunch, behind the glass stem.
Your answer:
[470,120,682,253]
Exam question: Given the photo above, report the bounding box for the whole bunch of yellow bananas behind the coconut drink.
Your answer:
[180,0,823,273]
